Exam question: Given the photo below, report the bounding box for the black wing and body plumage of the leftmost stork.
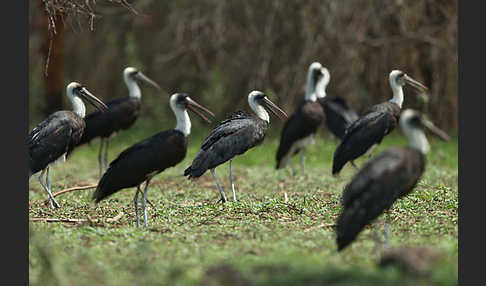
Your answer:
[27,110,85,176]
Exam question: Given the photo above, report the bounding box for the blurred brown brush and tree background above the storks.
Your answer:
[29,0,458,134]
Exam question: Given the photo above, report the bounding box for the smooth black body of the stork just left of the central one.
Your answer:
[93,129,188,202]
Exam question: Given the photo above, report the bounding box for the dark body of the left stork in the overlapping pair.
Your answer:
[276,100,324,169]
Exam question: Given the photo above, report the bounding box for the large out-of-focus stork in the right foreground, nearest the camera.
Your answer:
[336,109,449,251]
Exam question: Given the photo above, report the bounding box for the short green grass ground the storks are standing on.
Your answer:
[29,120,458,285]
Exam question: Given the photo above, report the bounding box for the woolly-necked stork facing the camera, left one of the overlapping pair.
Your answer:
[276,62,331,175]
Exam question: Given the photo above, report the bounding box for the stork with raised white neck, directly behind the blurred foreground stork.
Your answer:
[332,70,427,175]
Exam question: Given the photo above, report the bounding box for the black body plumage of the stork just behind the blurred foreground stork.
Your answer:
[332,101,401,174]
